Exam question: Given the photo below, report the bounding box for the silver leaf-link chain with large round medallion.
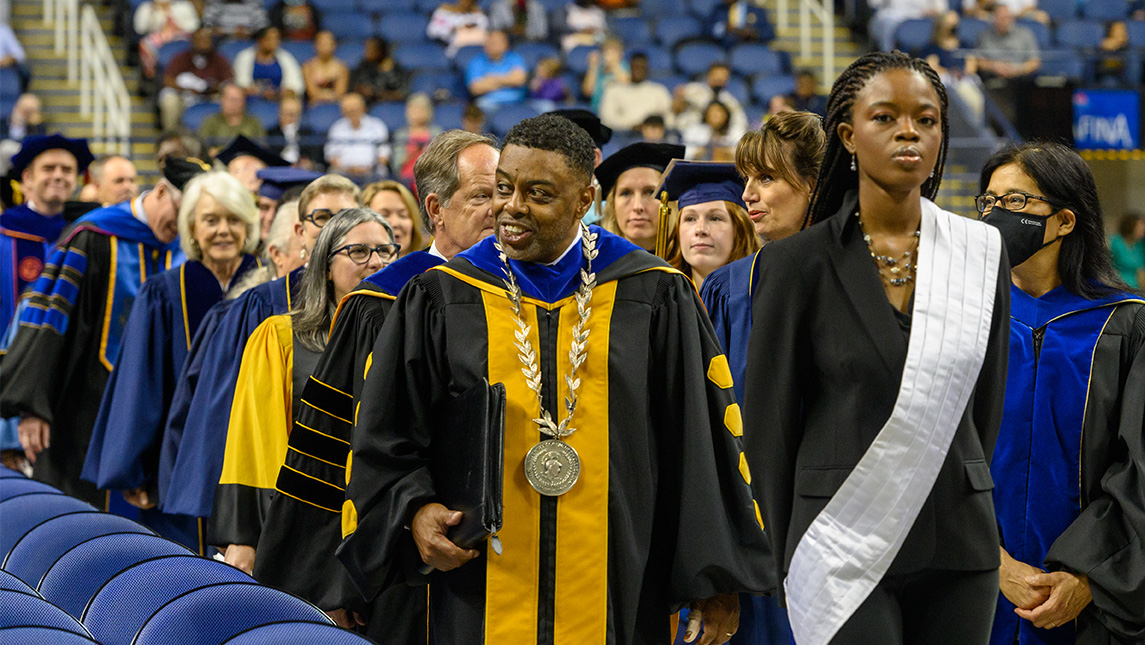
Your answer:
[493,223,598,497]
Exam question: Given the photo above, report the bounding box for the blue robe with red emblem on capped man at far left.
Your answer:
[0,204,68,337]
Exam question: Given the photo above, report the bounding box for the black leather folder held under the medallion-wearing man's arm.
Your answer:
[431,379,505,549]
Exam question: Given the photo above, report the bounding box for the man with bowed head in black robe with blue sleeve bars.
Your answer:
[0,154,208,508]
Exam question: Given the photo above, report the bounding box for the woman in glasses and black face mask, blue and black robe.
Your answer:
[977,142,1145,645]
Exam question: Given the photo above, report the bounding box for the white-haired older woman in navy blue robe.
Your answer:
[82,172,260,552]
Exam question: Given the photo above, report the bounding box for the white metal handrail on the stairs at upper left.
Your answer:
[44,0,132,156]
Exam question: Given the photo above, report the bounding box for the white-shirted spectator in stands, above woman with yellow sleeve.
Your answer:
[325,93,390,183]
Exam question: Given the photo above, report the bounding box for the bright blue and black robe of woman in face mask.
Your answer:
[990,286,1145,645]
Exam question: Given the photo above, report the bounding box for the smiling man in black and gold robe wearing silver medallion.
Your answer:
[338,116,773,645]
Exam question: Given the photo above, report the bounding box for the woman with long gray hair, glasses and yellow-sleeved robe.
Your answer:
[208,209,400,573]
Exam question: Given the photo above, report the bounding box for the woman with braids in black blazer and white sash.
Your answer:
[744,52,1009,645]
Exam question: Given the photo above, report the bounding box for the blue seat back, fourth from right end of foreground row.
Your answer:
[35,533,190,619]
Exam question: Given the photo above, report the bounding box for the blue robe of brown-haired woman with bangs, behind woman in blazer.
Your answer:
[691,251,791,645]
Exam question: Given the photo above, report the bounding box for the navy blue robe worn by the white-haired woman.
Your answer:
[82,255,259,552]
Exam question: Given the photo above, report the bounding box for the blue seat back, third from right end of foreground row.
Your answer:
[80,556,255,643]
